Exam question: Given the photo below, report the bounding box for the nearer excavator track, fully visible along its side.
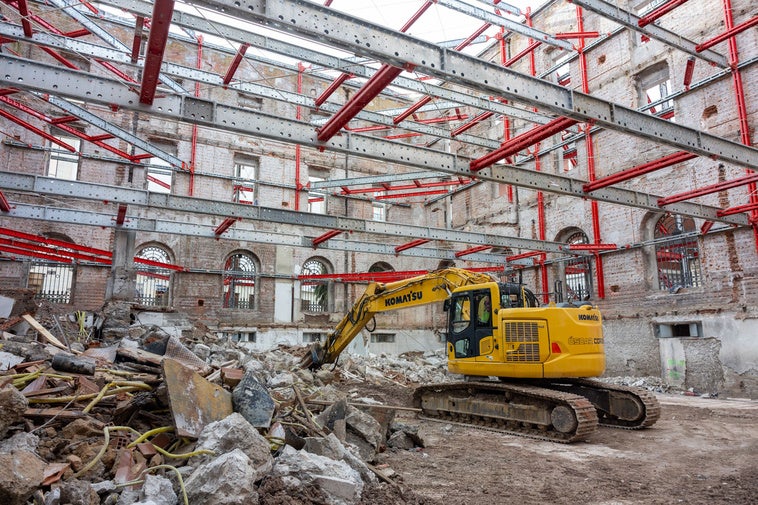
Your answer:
[413,382,598,443]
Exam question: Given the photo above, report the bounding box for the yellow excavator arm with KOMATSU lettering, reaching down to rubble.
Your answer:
[301,268,493,368]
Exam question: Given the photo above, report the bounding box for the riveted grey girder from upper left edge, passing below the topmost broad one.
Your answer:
[0,54,748,228]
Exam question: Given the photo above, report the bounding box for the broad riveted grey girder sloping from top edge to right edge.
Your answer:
[190,0,758,169]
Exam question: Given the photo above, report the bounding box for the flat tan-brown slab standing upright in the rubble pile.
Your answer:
[163,359,232,438]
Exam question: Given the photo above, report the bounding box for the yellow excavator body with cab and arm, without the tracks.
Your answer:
[304,268,605,379]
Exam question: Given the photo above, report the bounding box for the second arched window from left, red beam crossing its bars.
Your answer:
[134,245,171,307]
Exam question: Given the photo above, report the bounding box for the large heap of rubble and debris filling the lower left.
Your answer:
[0,303,434,505]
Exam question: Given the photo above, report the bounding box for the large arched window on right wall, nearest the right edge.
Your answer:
[653,214,701,290]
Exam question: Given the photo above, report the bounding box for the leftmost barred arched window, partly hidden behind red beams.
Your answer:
[26,233,75,303]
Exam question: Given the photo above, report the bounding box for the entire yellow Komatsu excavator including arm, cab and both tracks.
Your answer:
[302,268,660,443]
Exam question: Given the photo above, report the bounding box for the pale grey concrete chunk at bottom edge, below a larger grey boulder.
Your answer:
[185,449,258,505]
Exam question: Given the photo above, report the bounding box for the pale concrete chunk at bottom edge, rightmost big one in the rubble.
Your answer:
[272,446,363,505]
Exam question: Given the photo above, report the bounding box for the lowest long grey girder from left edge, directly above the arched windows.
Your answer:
[0,203,556,268]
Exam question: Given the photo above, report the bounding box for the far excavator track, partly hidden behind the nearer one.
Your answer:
[542,379,661,430]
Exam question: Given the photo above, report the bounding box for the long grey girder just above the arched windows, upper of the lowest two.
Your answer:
[0,172,588,254]
